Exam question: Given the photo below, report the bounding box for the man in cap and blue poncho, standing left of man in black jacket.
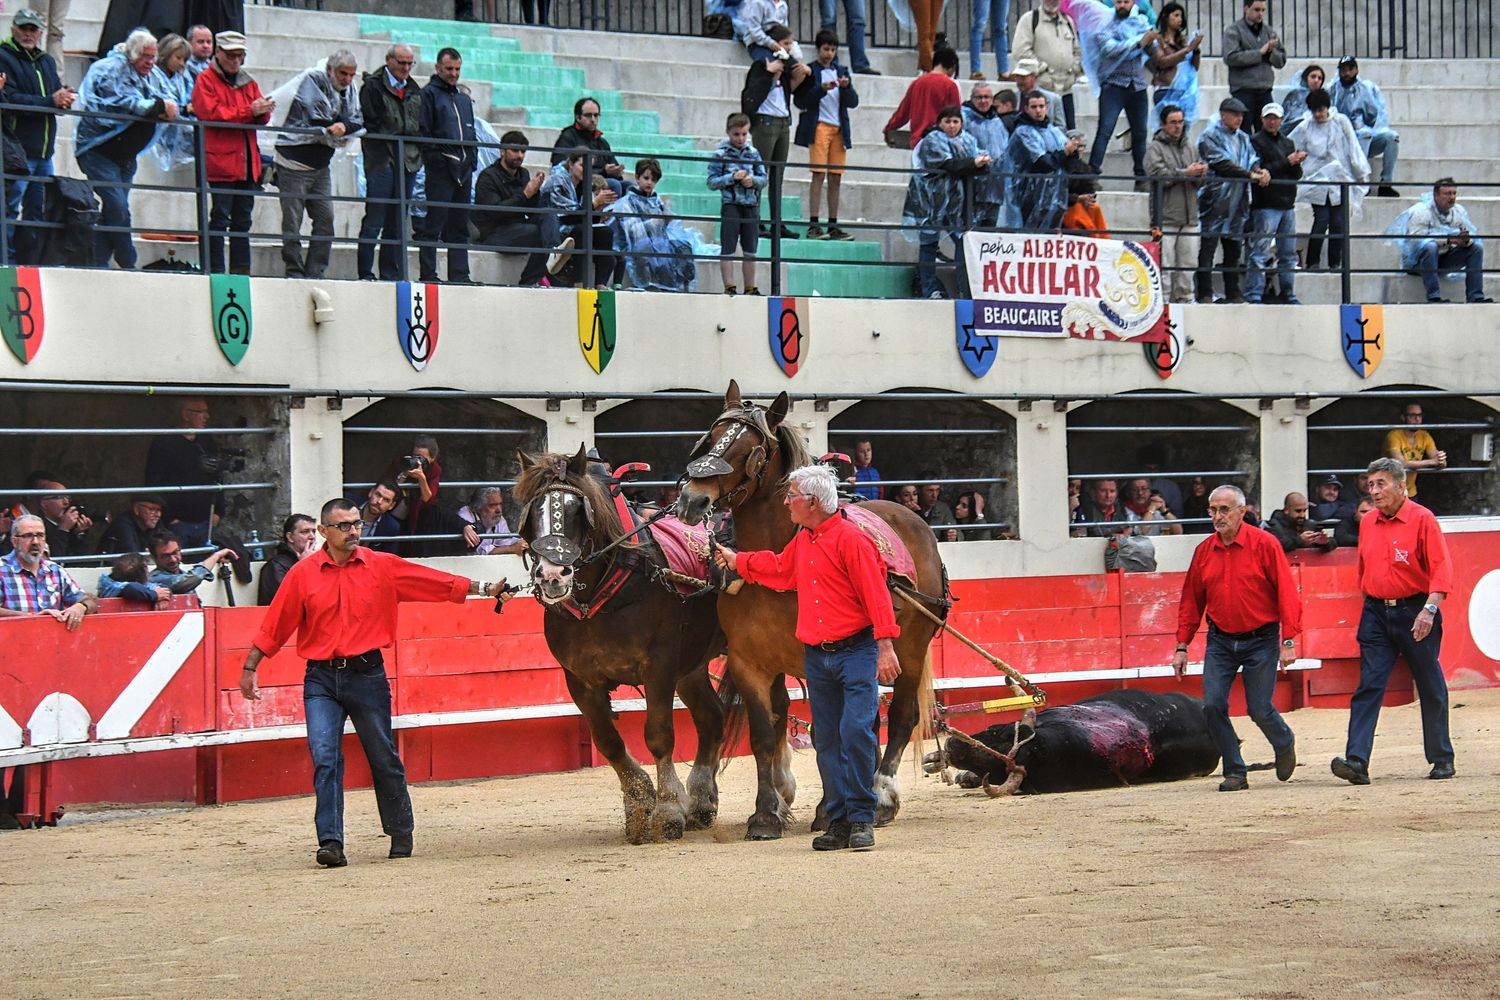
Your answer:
[1194,97,1271,303]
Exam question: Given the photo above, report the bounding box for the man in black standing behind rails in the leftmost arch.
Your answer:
[146,396,249,551]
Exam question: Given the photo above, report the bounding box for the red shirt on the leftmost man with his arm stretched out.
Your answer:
[254,546,470,660]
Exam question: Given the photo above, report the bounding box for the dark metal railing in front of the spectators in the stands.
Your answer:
[0,103,1500,307]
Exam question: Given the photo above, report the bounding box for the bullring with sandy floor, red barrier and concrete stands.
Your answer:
[0,0,1500,1000]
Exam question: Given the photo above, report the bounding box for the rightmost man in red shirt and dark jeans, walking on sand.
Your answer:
[1334,459,1454,784]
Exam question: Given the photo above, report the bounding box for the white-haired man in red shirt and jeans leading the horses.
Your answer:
[714,465,902,850]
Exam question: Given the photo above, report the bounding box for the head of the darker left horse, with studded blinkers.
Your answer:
[516,445,609,604]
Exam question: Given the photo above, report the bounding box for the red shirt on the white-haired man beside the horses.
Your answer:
[735,511,902,646]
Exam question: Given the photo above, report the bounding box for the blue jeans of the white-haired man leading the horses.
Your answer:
[803,639,881,823]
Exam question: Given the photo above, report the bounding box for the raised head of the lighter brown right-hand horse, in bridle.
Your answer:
[677,379,792,525]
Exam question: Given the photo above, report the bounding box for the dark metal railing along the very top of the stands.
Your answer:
[456,0,1500,59]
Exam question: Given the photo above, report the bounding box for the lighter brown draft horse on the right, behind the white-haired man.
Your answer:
[677,381,945,840]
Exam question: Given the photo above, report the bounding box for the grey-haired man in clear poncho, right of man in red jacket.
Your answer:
[276,48,365,277]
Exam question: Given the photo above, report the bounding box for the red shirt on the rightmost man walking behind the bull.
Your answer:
[1359,498,1454,598]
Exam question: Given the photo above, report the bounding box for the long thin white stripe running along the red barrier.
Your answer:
[0,660,1323,768]
